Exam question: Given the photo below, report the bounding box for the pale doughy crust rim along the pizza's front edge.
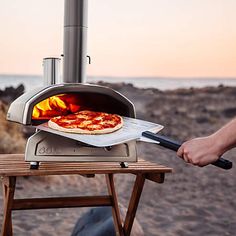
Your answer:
[48,111,124,134]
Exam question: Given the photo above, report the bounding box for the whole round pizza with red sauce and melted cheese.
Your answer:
[48,110,123,134]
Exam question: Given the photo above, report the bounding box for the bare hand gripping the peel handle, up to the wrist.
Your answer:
[177,136,222,167]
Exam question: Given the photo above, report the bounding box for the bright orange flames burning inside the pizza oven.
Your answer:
[32,94,81,119]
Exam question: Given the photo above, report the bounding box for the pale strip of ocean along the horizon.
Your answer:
[0,75,236,91]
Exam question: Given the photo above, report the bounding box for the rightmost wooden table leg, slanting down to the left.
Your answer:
[124,174,145,236]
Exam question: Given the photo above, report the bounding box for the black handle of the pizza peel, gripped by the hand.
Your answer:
[142,131,233,170]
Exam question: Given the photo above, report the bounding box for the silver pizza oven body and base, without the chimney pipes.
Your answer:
[7,83,137,168]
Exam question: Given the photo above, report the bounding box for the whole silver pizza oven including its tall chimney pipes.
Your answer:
[7,0,137,168]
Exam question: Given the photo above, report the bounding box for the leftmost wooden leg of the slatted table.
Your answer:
[1,177,16,236]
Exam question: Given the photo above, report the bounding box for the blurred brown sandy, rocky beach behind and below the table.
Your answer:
[0,82,236,236]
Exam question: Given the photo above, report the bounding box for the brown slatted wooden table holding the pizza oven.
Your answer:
[0,154,172,236]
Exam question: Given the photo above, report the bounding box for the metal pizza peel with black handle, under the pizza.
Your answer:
[36,117,232,170]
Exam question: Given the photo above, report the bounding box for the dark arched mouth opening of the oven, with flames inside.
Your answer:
[30,92,132,125]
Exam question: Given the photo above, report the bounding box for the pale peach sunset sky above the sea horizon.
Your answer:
[0,0,236,77]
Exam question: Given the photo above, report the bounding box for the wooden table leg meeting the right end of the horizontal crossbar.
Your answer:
[106,174,124,236]
